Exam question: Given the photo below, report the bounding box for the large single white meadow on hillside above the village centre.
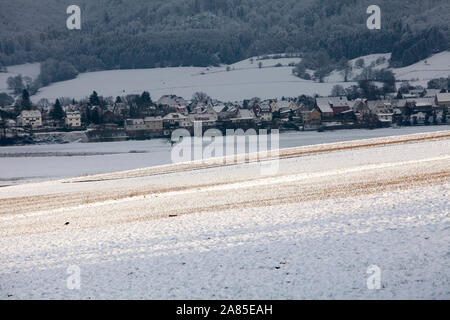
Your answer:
[32,57,351,102]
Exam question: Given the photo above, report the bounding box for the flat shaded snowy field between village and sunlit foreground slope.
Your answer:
[0,125,450,186]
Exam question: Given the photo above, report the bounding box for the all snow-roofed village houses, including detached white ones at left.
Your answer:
[6,93,450,137]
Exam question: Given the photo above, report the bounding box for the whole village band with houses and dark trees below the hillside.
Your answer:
[0,89,450,145]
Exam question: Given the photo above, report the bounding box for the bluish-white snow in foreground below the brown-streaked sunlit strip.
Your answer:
[0,184,450,299]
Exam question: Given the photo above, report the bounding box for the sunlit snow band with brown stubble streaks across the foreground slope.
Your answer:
[0,131,450,237]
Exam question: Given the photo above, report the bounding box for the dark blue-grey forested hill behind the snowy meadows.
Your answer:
[0,0,450,77]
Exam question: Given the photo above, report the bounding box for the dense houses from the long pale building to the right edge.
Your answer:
[118,93,450,136]
